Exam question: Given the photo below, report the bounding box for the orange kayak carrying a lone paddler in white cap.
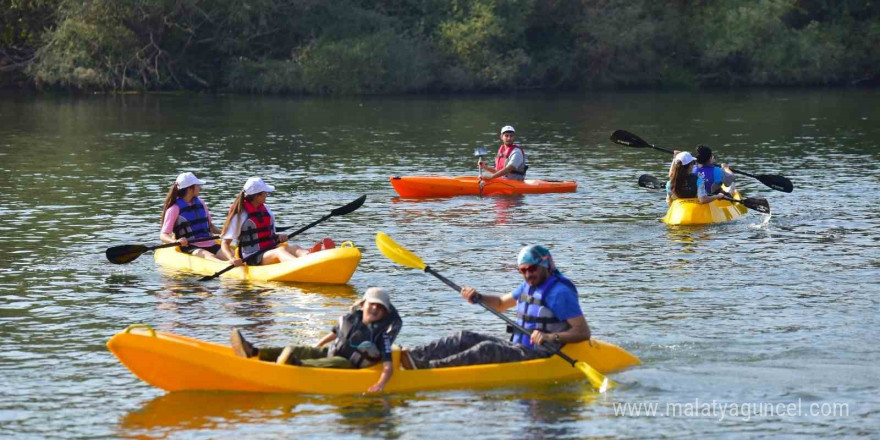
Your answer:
[391,176,577,197]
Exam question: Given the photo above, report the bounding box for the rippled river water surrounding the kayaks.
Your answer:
[0,90,880,439]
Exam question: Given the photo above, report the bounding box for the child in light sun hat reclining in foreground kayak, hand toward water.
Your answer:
[230,287,403,393]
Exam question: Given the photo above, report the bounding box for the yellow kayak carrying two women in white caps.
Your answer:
[154,241,361,284]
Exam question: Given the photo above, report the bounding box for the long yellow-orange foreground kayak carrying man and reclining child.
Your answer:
[107,325,640,394]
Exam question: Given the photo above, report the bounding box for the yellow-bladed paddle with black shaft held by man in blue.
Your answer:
[376,232,616,393]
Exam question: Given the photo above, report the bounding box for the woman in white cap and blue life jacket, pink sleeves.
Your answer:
[159,172,226,261]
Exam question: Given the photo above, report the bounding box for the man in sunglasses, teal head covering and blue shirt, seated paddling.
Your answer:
[403,246,590,369]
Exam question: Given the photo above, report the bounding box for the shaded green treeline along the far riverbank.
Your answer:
[0,0,880,94]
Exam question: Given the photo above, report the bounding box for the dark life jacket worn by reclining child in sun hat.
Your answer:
[327,306,403,368]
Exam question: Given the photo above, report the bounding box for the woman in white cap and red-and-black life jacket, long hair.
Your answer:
[220,177,309,266]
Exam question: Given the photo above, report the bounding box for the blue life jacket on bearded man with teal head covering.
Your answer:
[510,275,577,347]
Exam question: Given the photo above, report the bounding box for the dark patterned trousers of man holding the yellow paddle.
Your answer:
[408,331,553,368]
